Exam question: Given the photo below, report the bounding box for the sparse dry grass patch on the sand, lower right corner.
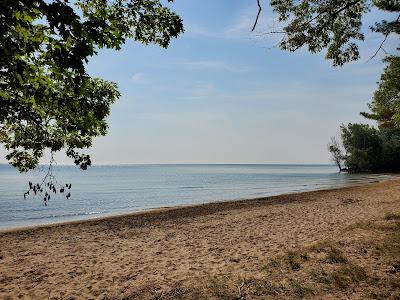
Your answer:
[198,213,400,300]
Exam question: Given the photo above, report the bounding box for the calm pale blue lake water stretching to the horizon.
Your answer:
[0,165,391,229]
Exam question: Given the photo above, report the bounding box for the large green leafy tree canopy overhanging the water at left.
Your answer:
[0,0,183,172]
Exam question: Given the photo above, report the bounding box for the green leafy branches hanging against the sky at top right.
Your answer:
[271,0,400,66]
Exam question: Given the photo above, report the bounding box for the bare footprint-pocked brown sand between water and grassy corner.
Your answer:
[0,179,400,299]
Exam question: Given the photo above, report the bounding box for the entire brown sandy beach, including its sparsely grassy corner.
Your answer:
[0,179,400,299]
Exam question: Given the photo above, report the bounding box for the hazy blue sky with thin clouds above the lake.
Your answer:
[3,0,398,164]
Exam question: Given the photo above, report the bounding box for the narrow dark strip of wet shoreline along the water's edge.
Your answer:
[0,174,400,235]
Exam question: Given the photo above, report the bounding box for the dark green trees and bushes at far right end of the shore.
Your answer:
[328,56,400,173]
